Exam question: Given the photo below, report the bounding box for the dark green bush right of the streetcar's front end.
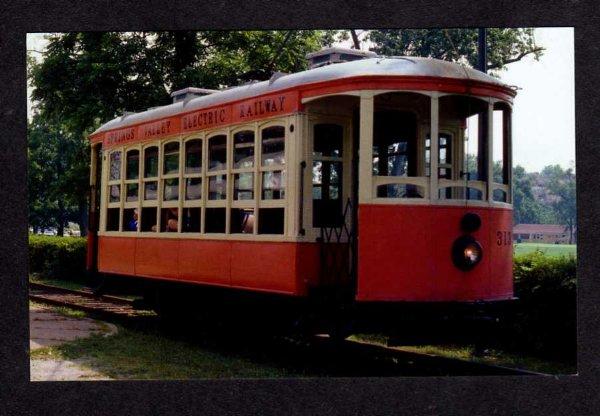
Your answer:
[508,251,577,360]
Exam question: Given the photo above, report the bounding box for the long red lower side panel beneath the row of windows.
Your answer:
[98,236,319,295]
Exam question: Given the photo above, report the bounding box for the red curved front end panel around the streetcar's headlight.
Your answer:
[357,205,513,302]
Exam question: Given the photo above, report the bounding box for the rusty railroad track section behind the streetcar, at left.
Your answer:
[29,282,153,319]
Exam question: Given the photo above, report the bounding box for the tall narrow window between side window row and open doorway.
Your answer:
[312,124,344,227]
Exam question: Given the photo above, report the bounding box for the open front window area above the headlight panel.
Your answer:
[361,91,512,206]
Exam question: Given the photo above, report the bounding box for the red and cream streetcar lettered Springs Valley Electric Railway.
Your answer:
[87,48,516,334]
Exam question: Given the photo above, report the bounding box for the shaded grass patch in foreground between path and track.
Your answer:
[31,327,293,380]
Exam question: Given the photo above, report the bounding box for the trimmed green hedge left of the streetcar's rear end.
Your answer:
[29,234,87,281]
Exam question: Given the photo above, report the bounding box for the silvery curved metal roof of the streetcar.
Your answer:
[92,57,509,135]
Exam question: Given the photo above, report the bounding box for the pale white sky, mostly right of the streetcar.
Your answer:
[27,28,575,171]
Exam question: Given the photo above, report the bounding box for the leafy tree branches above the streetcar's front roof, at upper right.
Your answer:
[369,28,544,75]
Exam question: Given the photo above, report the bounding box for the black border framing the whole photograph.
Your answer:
[0,0,600,415]
